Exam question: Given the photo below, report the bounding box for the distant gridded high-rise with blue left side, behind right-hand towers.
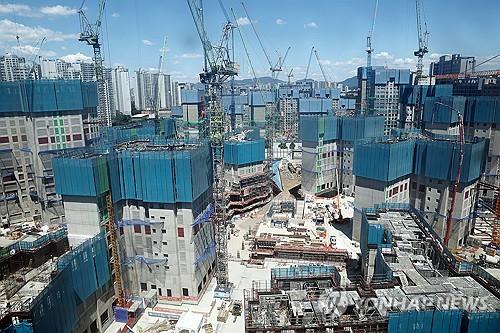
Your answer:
[356,67,410,135]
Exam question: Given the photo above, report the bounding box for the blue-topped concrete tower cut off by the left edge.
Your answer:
[0,80,97,226]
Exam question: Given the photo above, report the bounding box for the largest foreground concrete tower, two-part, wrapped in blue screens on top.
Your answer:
[53,136,215,303]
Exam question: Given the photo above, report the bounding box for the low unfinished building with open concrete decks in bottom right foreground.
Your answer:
[244,205,500,333]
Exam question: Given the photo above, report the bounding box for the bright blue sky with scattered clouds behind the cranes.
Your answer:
[0,0,500,82]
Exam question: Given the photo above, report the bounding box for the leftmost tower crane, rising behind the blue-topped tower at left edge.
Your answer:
[78,0,111,127]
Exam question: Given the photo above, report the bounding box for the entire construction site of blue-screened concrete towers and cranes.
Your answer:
[0,0,500,333]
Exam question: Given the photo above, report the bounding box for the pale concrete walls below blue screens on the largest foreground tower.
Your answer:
[119,202,215,303]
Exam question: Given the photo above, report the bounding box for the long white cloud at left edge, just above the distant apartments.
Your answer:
[0,19,77,42]
